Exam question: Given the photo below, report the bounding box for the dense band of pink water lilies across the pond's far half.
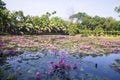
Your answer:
[0,35,120,54]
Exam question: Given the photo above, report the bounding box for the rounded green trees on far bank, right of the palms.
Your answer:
[68,13,120,35]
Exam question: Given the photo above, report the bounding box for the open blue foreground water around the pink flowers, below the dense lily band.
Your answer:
[0,50,120,80]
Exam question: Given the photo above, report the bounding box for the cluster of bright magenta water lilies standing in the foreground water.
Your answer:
[49,58,77,80]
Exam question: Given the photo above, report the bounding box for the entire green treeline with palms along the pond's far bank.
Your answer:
[0,0,120,36]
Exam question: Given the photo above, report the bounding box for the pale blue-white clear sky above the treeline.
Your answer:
[3,0,120,20]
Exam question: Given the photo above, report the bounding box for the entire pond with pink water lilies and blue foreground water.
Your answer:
[0,35,120,80]
